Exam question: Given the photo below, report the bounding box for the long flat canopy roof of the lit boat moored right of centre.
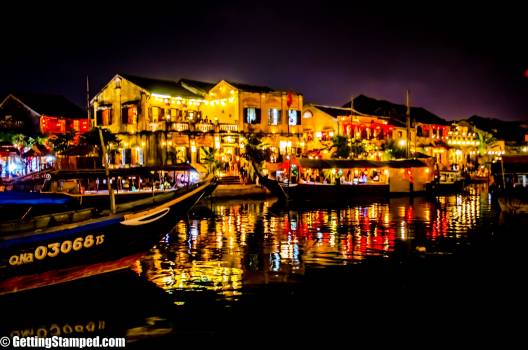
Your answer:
[297,158,427,169]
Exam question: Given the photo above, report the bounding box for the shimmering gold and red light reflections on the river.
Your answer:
[135,186,494,305]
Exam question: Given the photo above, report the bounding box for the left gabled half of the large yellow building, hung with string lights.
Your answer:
[91,74,208,166]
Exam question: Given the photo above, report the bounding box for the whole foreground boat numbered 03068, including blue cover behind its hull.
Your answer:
[0,171,216,279]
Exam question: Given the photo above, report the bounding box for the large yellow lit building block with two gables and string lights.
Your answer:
[91,74,303,166]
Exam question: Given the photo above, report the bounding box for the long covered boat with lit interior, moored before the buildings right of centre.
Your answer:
[261,158,430,201]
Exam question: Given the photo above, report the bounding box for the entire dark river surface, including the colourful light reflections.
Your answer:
[0,185,528,348]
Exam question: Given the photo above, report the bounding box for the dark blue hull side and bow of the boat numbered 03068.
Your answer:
[0,182,211,283]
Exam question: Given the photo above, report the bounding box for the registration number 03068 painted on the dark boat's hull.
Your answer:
[9,235,104,266]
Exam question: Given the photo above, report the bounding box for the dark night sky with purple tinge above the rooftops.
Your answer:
[0,0,528,120]
